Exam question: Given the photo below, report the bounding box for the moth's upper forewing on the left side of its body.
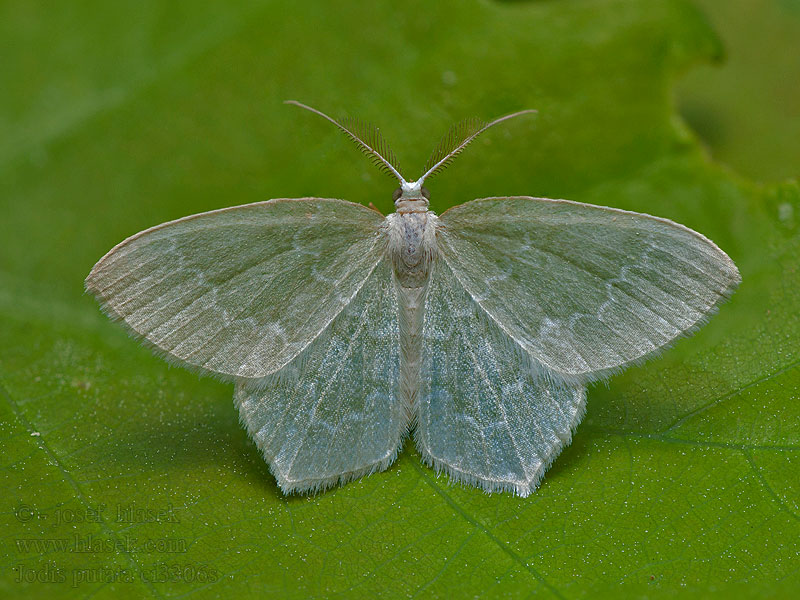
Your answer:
[86,198,385,382]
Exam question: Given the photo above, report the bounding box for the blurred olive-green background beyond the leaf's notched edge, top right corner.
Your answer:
[676,0,800,181]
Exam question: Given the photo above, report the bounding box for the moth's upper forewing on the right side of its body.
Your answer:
[437,197,741,384]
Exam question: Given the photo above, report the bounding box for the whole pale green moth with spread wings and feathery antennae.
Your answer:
[86,101,741,497]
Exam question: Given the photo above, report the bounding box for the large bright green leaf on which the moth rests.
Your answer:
[0,0,800,598]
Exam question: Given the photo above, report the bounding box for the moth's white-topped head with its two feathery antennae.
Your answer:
[284,100,536,208]
